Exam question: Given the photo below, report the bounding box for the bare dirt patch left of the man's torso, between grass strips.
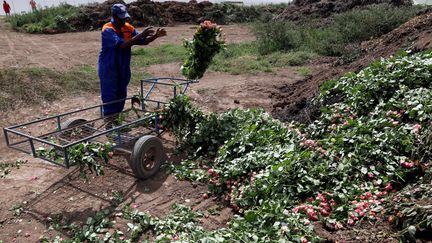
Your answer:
[0,18,100,70]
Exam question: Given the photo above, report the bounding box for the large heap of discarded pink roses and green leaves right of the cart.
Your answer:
[167,52,432,242]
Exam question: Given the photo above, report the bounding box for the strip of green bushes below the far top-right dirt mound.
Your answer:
[254,4,424,56]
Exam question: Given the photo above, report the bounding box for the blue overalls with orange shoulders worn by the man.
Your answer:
[98,19,138,116]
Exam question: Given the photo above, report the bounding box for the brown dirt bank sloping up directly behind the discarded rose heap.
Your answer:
[272,9,432,123]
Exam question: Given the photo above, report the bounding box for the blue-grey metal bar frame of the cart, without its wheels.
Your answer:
[3,77,198,168]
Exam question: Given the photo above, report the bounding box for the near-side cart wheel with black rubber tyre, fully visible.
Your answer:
[128,135,166,179]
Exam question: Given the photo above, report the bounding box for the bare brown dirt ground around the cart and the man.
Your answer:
[0,19,308,242]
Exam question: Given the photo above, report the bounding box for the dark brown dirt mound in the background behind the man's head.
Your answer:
[70,0,212,31]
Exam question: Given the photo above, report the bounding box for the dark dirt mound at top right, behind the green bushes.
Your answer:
[275,0,413,21]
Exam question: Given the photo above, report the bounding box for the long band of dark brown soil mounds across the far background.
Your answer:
[69,0,412,31]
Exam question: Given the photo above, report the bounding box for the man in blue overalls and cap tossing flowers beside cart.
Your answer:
[98,4,166,120]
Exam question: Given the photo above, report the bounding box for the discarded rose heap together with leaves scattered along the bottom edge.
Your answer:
[44,51,432,243]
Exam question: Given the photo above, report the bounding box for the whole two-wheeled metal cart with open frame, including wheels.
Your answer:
[3,78,198,179]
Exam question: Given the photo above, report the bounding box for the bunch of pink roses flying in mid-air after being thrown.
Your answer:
[181,20,225,79]
